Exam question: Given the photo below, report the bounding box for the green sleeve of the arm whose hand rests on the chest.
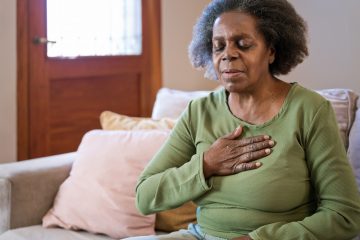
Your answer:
[136,103,211,214]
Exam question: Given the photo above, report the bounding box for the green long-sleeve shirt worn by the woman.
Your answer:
[137,83,360,240]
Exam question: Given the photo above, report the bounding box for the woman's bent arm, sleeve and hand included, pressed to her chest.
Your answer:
[136,100,274,214]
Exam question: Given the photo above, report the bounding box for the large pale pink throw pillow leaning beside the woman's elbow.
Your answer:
[43,130,169,238]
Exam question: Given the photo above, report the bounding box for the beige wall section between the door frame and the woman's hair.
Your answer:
[161,0,218,90]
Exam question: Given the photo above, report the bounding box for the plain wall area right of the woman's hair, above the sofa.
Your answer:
[285,0,360,93]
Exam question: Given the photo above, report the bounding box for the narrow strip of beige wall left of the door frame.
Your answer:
[0,0,16,163]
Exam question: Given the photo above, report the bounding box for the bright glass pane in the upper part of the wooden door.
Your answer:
[47,0,142,58]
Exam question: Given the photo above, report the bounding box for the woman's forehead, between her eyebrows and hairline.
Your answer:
[213,11,258,37]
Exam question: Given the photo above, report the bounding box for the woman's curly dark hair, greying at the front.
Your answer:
[189,0,308,79]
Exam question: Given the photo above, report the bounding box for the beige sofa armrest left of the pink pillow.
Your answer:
[0,153,76,234]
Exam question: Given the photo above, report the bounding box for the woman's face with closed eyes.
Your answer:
[212,11,275,92]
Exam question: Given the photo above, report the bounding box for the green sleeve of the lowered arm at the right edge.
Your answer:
[249,102,360,240]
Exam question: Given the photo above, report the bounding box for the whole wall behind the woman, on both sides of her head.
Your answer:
[162,0,360,93]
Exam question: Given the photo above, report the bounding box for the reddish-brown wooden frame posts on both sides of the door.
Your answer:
[16,0,162,161]
